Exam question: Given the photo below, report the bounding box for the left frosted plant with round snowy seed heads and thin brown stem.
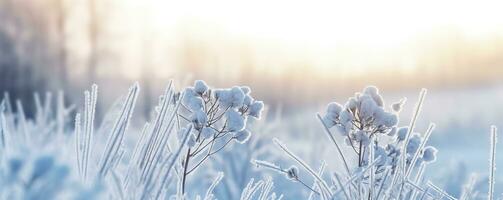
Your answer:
[178,80,264,194]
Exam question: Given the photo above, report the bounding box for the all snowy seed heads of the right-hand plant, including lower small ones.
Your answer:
[322,86,437,174]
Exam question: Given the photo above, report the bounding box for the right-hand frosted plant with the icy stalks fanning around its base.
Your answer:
[254,86,446,199]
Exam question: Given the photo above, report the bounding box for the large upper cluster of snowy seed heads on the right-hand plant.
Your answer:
[323,86,404,167]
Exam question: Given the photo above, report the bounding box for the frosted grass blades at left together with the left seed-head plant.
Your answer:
[0,81,272,200]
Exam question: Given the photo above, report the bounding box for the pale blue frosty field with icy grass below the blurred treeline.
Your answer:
[0,82,503,199]
